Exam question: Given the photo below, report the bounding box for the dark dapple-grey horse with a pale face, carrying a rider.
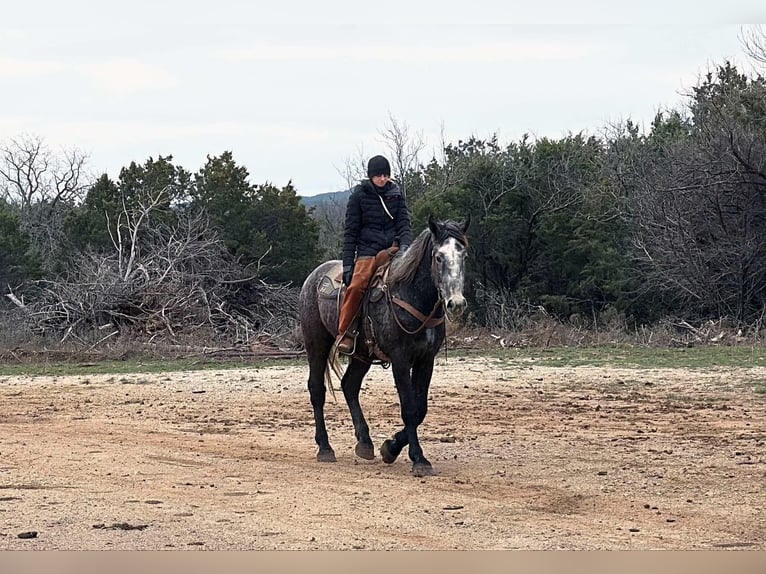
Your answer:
[298,216,470,476]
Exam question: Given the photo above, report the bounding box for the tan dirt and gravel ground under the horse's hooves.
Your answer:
[0,358,766,550]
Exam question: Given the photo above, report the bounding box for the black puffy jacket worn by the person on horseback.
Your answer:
[343,179,412,268]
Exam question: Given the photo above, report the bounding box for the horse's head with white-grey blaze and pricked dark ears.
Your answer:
[428,215,471,316]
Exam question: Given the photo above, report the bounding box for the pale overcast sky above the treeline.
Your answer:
[0,0,766,196]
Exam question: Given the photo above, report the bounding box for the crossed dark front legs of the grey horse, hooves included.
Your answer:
[380,358,434,476]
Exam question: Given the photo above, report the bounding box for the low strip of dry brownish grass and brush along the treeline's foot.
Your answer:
[0,310,766,362]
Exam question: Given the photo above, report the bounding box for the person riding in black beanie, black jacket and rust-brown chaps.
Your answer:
[337,155,412,354]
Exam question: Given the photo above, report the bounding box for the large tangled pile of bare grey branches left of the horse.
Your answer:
[14,189,298,349]
